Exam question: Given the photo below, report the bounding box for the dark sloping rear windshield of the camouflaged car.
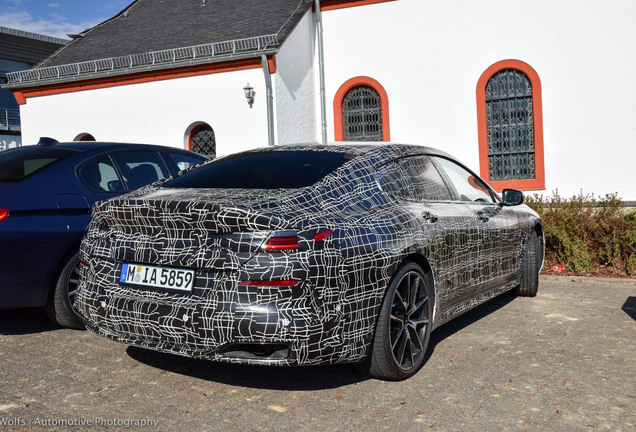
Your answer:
[165,150,351,189]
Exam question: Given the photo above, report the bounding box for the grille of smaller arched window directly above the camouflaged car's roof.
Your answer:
[342,86,383,141]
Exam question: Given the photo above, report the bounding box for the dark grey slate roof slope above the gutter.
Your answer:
[39,0,313,67]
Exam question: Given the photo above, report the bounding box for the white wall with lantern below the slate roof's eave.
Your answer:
[21,68,267,156]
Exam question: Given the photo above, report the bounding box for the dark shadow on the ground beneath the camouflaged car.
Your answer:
[127,293,516,391]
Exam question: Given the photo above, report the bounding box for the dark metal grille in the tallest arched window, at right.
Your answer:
[486,69,535,181]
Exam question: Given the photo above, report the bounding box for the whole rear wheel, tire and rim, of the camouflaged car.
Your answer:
[362,261,433,381]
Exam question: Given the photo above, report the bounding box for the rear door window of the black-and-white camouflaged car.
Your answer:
[398,155,451,201]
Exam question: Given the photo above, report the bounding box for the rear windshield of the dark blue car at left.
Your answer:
[0,146,75,183]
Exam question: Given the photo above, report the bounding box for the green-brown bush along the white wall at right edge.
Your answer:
[526,192,636,276]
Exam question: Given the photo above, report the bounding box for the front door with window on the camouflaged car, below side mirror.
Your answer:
[433,157,522,295]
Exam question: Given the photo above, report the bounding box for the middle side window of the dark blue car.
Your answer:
[112,151,170,190]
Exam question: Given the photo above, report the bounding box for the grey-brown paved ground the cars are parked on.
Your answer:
[0,276,636,432]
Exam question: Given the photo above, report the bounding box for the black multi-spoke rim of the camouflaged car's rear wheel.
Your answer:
[389,271,430,370]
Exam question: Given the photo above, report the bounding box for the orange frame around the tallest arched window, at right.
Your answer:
[477,60,545,192]
